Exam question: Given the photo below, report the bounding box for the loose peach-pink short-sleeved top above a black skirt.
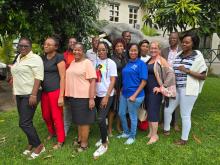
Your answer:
[65,59,96,98]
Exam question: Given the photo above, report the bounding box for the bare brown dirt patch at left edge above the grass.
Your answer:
[0,81,16,111]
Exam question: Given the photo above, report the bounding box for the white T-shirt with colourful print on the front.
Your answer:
[96,58,118,97]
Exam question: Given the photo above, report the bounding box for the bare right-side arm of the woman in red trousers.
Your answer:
[57,61,66,107]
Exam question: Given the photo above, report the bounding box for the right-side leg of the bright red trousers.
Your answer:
[48,89,65,143]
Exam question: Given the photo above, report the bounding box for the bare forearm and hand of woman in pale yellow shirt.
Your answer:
[29,79,41,106]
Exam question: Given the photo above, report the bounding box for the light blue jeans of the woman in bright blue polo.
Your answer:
[119,95,144,138]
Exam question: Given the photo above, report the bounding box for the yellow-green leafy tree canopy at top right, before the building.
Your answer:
[140,0,220,36]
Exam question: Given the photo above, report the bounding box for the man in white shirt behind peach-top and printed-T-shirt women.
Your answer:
[86,36,99,68]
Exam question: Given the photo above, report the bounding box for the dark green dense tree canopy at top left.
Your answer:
[0,0,105,49]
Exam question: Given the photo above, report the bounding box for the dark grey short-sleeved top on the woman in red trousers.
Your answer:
[42,54,64,92]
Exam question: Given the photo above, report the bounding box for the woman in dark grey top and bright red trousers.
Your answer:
[41,37,66,149]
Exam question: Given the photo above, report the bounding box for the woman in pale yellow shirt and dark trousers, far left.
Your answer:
[11,38,45,158]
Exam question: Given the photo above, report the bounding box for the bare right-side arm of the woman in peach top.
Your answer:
[89,78,96,110]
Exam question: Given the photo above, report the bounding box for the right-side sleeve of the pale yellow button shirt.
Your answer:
[31,55,44,81]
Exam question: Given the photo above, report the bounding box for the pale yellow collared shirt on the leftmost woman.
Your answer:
[11,51,44,95]
